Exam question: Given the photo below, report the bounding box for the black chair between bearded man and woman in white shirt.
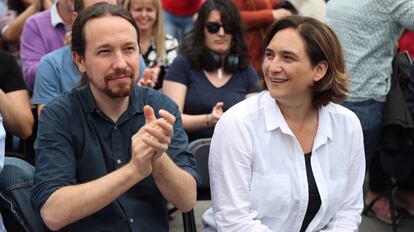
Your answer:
[183,138,211,232]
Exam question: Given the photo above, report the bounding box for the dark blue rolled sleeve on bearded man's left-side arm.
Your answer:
[32,98,76,210]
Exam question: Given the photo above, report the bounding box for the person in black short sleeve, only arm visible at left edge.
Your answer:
[0,49,34,139]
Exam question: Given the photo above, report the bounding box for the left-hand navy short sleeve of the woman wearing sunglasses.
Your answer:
[164,54,191,86]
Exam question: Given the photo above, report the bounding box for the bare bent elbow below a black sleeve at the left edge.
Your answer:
[0,89,34,139]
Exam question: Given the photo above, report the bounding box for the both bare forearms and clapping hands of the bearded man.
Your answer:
[40,106,196,230]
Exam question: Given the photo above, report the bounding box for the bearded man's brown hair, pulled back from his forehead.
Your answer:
[72,2,140,57]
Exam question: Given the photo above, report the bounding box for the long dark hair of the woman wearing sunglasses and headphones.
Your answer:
[182,0,249,70]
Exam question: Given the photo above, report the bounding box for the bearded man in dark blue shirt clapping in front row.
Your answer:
[32,3,198,231]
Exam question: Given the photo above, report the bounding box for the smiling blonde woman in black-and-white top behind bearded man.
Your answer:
[125,0,178,89]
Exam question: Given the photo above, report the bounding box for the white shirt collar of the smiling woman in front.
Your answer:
[263,91,333,141]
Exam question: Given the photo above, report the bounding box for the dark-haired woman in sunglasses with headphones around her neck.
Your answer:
[163,0,260,141]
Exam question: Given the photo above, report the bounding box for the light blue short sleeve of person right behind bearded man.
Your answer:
[32,55,64,105]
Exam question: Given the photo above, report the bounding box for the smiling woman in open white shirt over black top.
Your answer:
[203,16,365,232]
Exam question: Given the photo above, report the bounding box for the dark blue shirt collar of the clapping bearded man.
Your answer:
[79,84,144,116]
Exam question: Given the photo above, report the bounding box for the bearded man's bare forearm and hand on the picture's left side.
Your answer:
[40,116,155,230]
